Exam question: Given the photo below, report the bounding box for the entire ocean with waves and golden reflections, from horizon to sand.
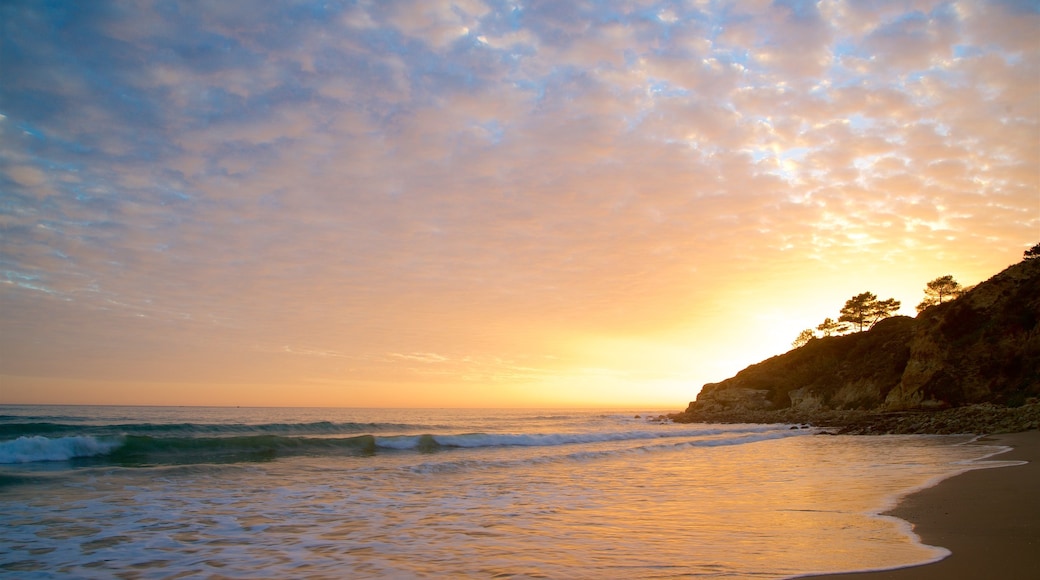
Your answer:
[0,405,1006,579]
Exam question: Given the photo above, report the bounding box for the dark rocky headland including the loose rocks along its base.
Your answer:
[669,259,1040,433]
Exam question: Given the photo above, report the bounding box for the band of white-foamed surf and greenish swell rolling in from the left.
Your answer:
[0,423,801,467]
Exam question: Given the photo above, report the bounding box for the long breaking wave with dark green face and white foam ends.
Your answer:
[0,423,804,467]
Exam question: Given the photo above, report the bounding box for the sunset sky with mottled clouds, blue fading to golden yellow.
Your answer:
[0,0,1040,411]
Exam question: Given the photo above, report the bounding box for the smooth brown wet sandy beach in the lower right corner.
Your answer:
[813,430,1040,580]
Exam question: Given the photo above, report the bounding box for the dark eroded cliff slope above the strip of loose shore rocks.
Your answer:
[686,260,1040,415]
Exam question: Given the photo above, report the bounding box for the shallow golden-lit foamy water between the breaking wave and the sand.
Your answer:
[0,436,998,578]
